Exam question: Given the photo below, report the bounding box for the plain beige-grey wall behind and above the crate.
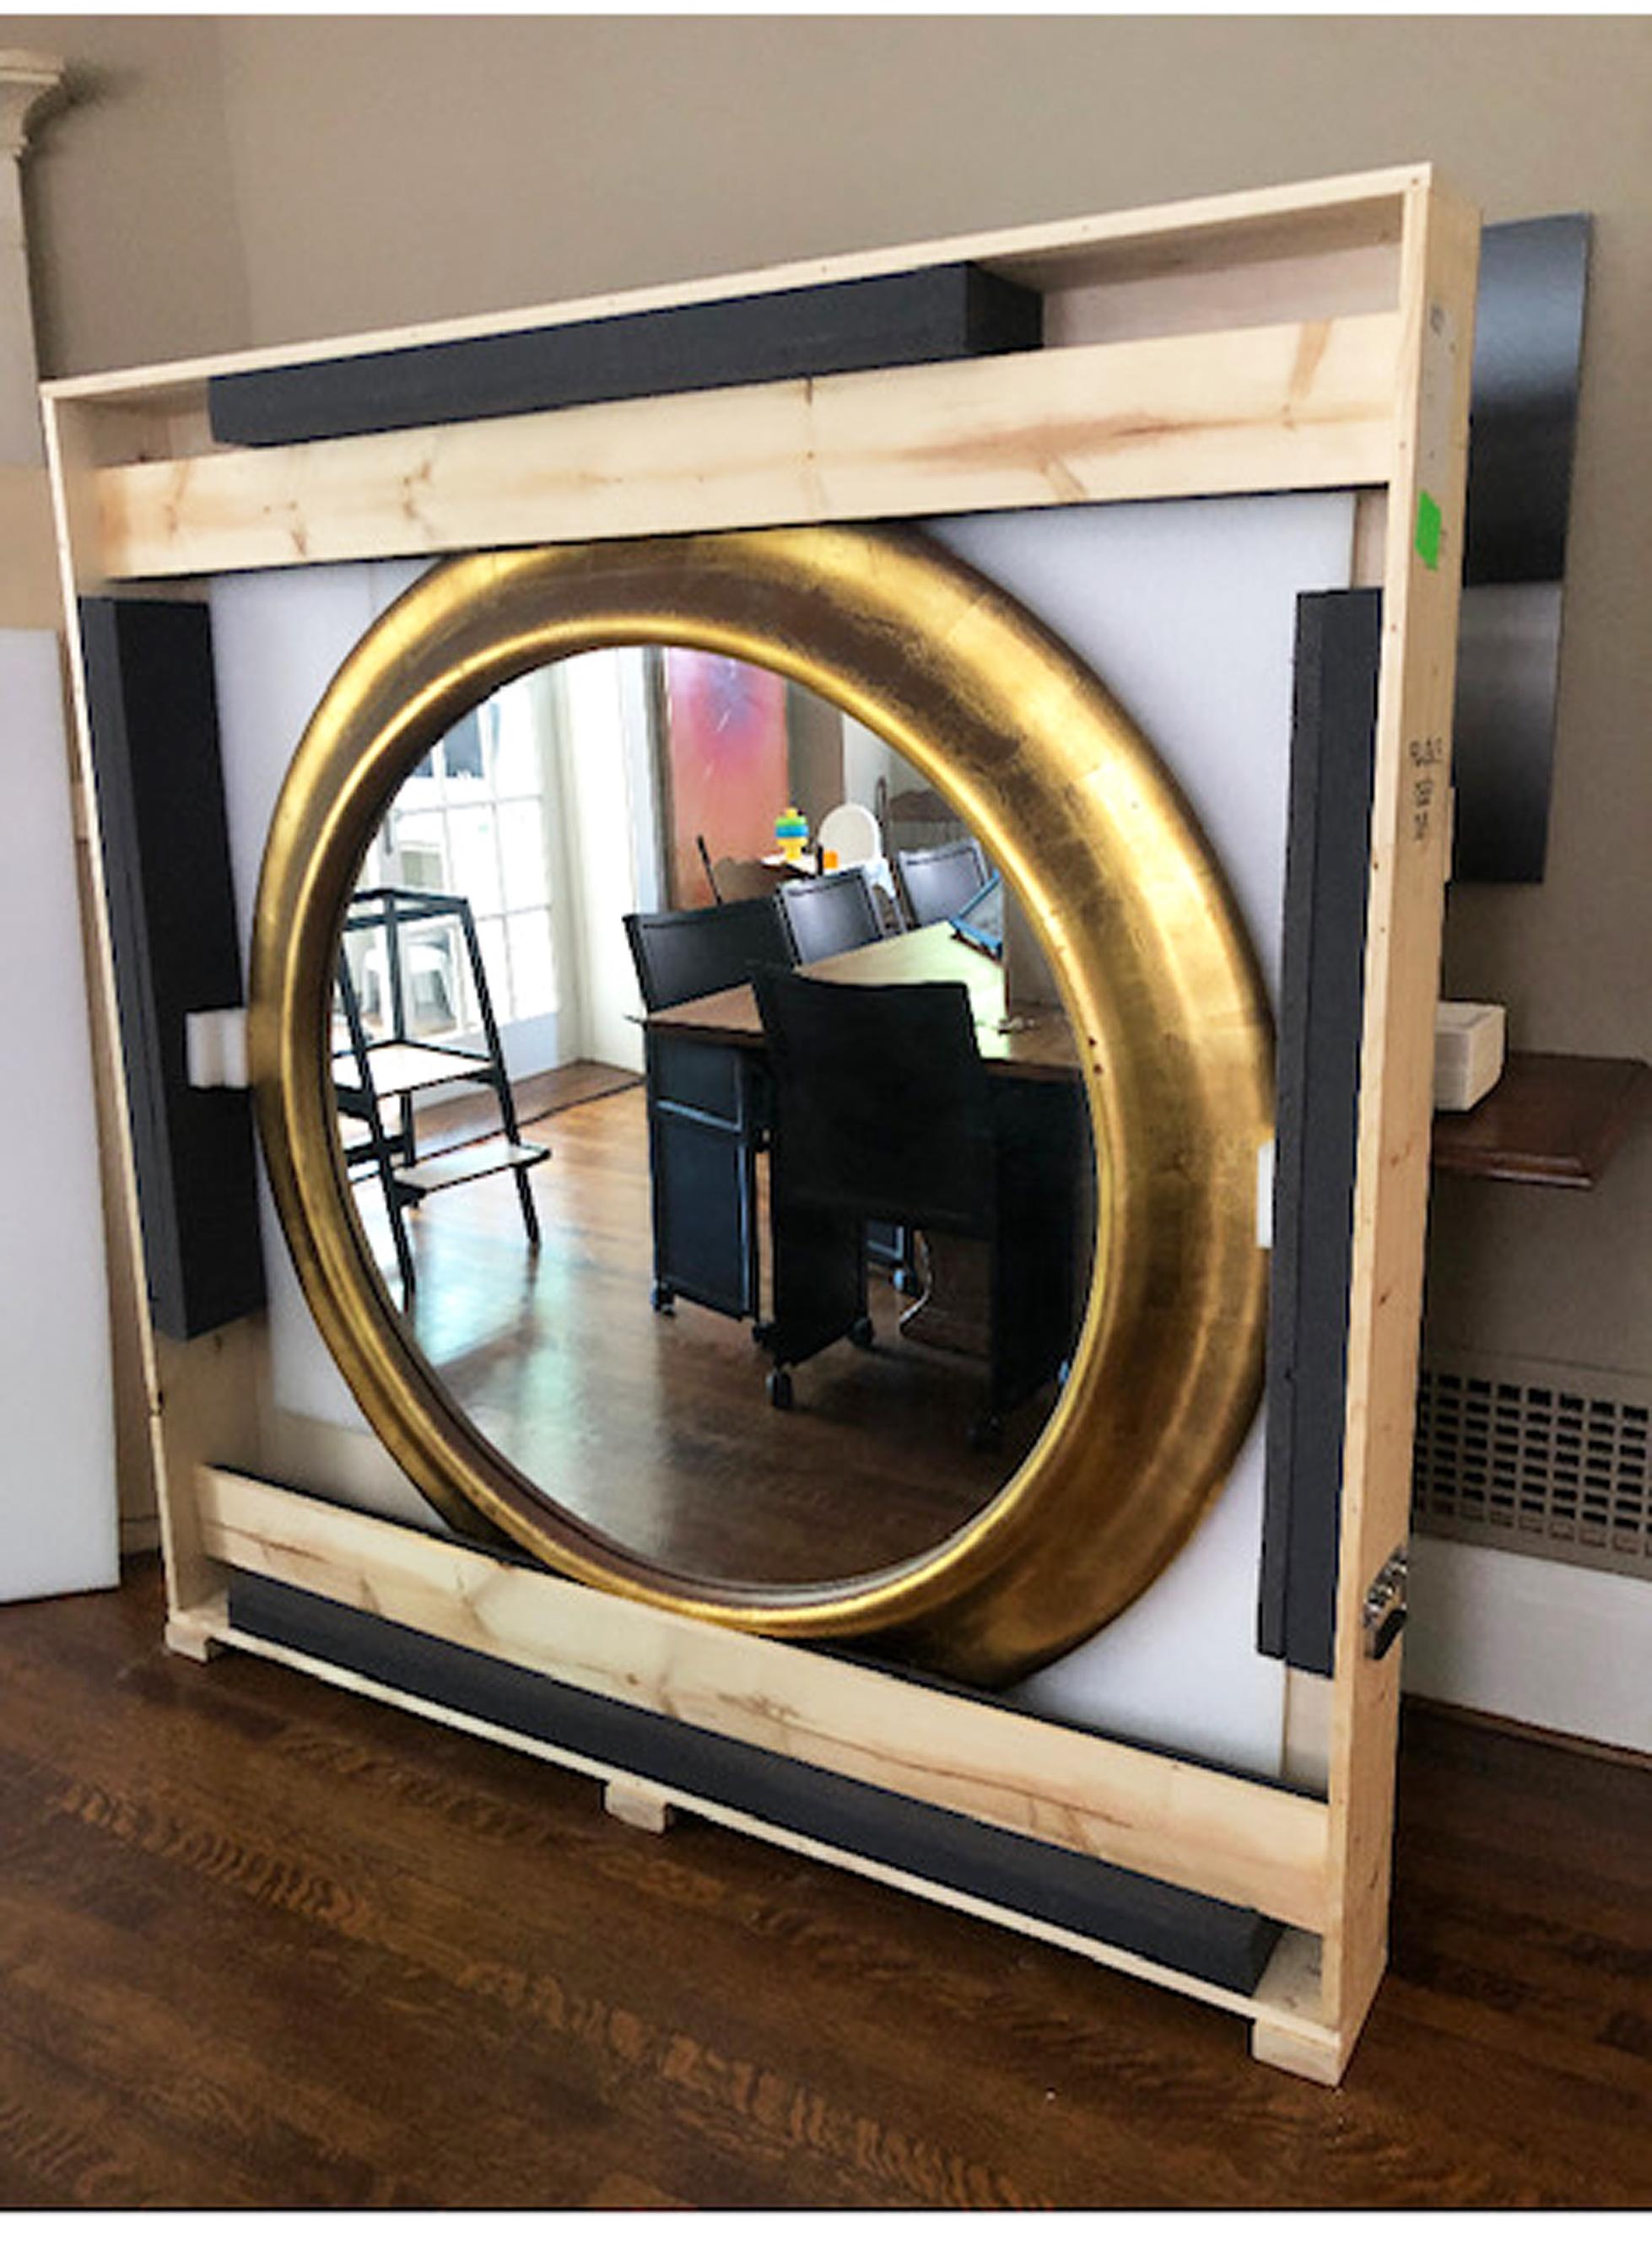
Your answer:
[13,16,1652,1370]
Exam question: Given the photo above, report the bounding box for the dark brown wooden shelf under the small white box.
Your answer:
[1433,1055,1652,1188]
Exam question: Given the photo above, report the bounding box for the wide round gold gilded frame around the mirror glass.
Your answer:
[250,526,1271,1683]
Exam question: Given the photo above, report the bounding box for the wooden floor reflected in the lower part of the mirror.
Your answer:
[360,1089,1066,1584]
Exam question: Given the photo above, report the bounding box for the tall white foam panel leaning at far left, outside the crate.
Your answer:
[0,630,119,1602]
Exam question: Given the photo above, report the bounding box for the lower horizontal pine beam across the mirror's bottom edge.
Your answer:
[200,1470,1328,1930]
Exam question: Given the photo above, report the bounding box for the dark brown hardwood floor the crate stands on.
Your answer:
[0,1568,1652,2210]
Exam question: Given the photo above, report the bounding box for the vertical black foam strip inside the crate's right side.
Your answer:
[1256,587,1382,1674]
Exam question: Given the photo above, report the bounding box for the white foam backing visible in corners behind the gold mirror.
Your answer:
[212,493,1352,1778]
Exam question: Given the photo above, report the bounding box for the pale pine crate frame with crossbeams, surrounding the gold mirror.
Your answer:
[47,166,1479,2084]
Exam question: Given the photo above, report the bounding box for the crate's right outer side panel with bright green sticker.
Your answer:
[1321,182,1479,2061]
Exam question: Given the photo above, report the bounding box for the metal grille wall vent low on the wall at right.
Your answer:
[1412,1355,1652,1578]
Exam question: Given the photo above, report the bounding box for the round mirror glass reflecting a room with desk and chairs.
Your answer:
[333,648,1093,1586]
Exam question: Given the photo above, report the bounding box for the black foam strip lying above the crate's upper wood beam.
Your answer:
[207,263,1045,445]
